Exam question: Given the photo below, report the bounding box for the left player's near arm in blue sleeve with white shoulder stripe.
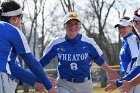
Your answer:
[9,28,54,93]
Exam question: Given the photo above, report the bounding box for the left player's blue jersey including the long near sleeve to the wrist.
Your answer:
[0,21,52,90]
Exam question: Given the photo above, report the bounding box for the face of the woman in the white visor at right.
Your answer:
[118,25,132,37]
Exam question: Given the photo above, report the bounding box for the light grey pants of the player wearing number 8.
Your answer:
[57,79,93,93]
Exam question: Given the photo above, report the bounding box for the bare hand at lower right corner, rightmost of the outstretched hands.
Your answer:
[119,80,133,93]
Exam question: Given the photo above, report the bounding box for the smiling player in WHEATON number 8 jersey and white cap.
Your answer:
[40,12,119,93]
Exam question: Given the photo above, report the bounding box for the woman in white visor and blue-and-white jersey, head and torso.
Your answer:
[115,17,139,73]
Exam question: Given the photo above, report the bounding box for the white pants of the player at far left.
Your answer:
[0,72,17,93]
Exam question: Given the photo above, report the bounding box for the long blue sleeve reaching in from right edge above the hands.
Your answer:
[116,66,140,87]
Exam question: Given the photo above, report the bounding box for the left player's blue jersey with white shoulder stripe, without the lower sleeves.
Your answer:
[0,21,30,74]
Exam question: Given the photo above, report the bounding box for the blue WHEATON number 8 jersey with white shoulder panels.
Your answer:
[40,34,105,78]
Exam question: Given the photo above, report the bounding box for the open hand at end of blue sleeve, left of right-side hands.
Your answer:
[104,80,117,92]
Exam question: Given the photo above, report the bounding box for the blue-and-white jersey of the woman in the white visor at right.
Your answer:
[119,33,140,72]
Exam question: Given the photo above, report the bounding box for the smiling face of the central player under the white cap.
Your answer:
[64,19,81,39]
